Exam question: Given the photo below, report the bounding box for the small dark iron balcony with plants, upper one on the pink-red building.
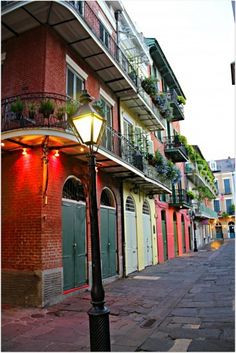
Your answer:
[164,135,188,163]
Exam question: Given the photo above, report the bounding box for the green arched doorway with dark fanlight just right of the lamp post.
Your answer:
[100,188,117,278]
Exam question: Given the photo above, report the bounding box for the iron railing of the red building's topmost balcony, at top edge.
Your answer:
[68,1,137,86]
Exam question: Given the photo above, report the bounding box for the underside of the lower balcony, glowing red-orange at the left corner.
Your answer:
[2,129,171,195]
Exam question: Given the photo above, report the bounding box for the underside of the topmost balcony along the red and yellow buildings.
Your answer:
[2,1,164,131]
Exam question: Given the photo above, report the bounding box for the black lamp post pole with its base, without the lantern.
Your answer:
[88,151,111,352]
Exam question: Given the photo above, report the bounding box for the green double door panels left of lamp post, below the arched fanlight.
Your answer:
[62,200,87,290]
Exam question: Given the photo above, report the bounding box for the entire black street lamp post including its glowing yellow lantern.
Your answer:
[69,91,111,352]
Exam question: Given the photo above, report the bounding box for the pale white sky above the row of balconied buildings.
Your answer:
[122,0,236,161]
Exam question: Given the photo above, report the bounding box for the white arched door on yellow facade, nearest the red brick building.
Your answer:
[125,196,138,274]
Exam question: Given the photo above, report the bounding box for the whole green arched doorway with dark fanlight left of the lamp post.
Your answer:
[62,177,88,290]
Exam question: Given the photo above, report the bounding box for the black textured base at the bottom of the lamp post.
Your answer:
[88,306,111,352]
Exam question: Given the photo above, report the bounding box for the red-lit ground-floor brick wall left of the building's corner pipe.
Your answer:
[2,147,42,270]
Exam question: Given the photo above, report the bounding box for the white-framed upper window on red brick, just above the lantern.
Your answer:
[66,66,84,100]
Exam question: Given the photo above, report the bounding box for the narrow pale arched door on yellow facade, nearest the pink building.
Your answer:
[143,200,152,266]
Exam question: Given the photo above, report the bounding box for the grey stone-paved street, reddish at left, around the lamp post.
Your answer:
[2,239,235,352]
